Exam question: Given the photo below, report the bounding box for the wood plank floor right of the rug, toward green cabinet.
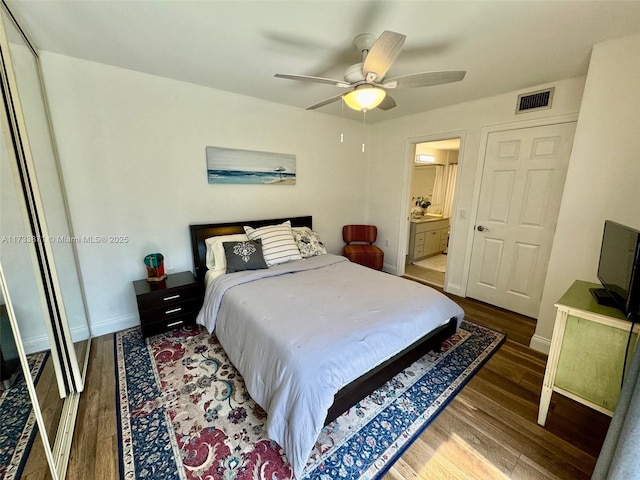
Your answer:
[384,288,610,480]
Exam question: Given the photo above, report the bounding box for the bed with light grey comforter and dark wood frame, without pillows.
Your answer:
[190,216,464,477]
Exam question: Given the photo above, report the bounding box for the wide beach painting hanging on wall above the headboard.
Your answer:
[206,147,296,185]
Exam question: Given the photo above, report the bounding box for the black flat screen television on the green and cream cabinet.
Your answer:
[592,220,640,320]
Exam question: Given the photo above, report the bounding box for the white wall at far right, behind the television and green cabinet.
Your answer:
[532,34,640,351]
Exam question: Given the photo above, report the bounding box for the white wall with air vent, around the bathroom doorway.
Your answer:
[366,77,585,295]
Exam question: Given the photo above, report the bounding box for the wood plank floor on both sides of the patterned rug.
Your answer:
[61,286,609,480]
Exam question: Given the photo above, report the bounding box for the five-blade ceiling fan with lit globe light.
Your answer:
[275,30,467,112]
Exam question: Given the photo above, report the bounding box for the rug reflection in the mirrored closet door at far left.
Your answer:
[0,352,49,480]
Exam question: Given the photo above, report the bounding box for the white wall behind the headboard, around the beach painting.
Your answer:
[41,52,367,335]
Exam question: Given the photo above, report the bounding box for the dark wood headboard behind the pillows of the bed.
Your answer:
[189,216,313,282]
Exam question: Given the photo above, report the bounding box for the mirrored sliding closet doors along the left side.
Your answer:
[0,3,91,478]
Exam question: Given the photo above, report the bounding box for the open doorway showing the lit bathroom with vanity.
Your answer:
[405,138,460,288]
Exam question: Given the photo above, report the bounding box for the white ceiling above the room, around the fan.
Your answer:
[6,0,640,122]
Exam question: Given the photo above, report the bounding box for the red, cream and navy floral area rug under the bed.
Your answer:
[115,322,505,480]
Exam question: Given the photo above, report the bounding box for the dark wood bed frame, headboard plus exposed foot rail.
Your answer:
[189,216,457,425]
